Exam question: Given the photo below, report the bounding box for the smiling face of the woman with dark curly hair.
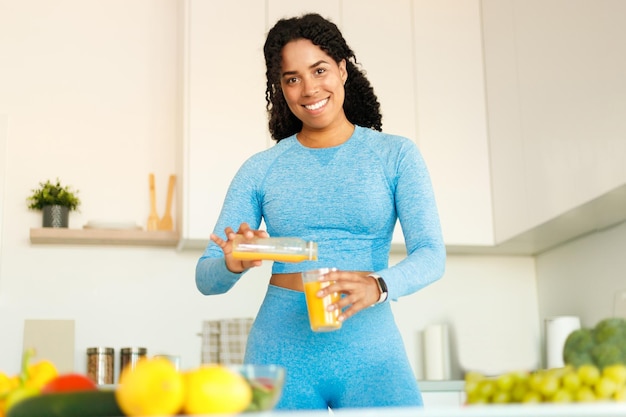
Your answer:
[280,39,348,131]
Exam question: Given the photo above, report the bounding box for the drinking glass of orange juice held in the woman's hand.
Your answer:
[302,268,341,332]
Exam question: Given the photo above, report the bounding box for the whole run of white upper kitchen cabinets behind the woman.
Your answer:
[179,0,626,254]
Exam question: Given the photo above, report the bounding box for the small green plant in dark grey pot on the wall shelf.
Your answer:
[27,178,80,227]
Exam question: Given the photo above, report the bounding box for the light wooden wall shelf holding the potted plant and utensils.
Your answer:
[30,227,180,247]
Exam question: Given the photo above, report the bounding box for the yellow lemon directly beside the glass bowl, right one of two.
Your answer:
[183,365,252,414]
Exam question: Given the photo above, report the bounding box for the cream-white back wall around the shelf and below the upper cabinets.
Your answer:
[0,0,539,377]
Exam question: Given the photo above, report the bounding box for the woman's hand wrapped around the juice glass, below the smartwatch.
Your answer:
[317,271,380,321]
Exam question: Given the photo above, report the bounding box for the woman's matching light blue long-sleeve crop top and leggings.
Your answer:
[196,126,446,409]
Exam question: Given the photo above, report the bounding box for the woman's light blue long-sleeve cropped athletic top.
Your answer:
[196,126,446,299]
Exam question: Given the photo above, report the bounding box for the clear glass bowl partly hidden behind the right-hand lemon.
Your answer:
[232,364,285,412]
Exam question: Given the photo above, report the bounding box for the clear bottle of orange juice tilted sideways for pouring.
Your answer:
[233,235,317,262]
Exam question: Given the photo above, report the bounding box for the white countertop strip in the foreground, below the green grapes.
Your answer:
[250,403,626,417]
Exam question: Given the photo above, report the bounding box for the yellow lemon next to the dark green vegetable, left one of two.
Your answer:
[115,357,185,417]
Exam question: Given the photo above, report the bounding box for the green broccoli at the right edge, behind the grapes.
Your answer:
[563,318,626,369]
